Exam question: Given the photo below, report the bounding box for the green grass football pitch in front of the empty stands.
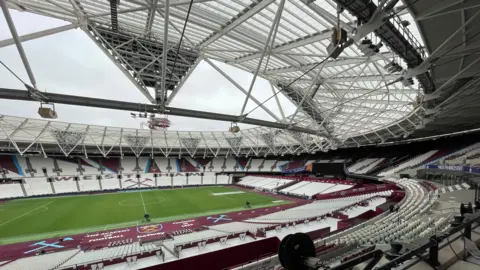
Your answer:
[0,186,289,244]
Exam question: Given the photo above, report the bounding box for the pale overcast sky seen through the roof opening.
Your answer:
[0,10,294,131]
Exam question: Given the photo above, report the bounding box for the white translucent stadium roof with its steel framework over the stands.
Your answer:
[0,0,468,154]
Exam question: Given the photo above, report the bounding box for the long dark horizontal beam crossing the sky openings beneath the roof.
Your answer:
[0,88,326,136]
